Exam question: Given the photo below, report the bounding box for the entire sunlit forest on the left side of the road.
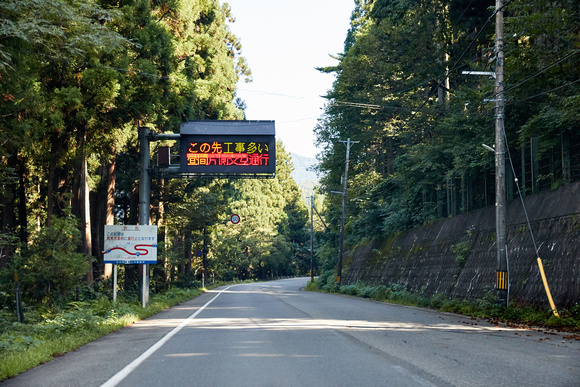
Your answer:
[0,0,309,307]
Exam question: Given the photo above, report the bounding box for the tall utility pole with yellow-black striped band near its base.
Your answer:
[494,0,509,306]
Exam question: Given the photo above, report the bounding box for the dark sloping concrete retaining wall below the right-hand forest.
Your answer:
[343,183,580,308]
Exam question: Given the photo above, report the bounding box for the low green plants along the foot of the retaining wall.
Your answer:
[306,271,580,334]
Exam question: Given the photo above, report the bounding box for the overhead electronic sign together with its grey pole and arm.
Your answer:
[124,120,276,307]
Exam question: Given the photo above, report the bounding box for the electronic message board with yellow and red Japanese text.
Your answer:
[180,120,276,176]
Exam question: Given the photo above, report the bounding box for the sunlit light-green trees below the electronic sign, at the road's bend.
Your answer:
[204,143,309,280]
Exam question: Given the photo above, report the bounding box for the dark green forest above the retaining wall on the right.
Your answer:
[315,0,580,272]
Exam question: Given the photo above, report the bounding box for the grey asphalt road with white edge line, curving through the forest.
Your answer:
[2,279,580,387]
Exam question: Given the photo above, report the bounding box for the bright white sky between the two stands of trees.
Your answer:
[222,0,354,157]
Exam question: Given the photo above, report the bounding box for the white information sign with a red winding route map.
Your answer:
[104,226,157,264]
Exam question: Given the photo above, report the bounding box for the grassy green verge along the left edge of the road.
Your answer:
[0,283,218,381]
